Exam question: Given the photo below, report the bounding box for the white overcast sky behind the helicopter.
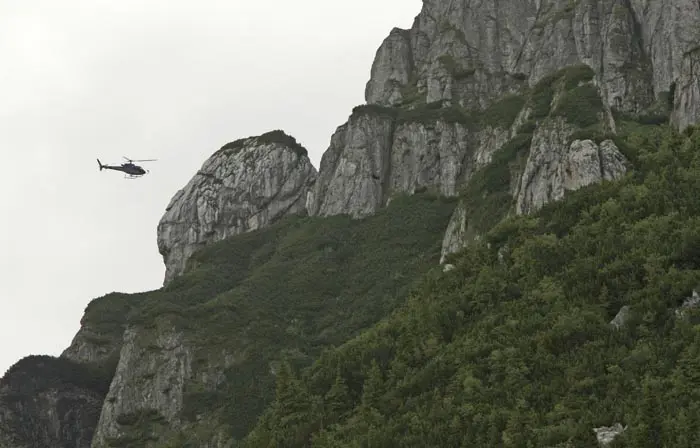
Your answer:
[0,0,422,375]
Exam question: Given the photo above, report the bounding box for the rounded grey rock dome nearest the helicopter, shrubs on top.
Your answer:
[158,131,316,283]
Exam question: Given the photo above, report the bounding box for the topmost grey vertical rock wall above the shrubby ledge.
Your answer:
[365,0,700,127]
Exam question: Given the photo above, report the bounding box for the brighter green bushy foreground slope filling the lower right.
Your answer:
[247,124,700,448]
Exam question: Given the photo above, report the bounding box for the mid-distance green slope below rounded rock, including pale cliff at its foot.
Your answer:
[80,193,455,448]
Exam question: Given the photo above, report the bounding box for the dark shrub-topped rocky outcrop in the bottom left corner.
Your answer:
[0,356,109,448]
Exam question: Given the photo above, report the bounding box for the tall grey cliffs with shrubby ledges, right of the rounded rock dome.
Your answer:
[309,0,700,252]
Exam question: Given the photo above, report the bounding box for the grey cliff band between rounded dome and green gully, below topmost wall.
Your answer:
[308,107,512,218]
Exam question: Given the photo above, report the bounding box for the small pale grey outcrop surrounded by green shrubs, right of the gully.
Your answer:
[515,119,627,214]
